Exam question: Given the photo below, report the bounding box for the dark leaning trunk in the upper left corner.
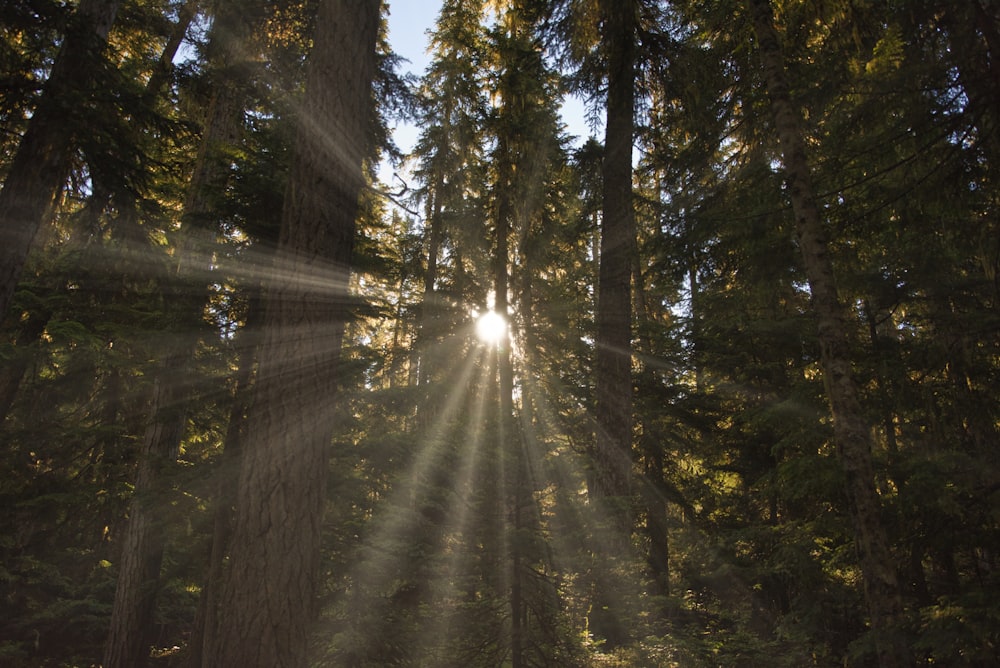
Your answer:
[0,0,121,317]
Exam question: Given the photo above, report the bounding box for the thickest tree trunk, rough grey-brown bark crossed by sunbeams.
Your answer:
[206,0,380,668]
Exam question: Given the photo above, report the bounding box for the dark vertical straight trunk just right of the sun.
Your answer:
[588,0,637,647]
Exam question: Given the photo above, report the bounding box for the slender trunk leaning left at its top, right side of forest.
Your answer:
[750,0,910,668]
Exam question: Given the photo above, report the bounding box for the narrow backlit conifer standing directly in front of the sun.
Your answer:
[487,2,572,667]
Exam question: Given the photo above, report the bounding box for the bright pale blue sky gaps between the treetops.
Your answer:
[389,0,592,167]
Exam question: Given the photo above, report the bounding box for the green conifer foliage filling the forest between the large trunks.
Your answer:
[0,0,1000,668]
